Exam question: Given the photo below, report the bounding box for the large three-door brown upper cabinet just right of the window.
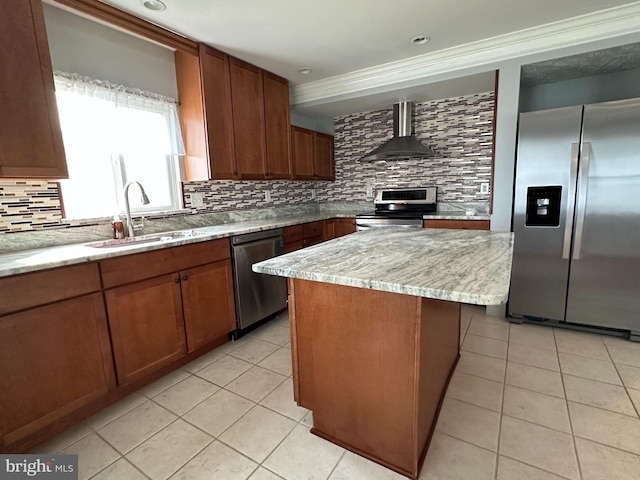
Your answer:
[175,45,291,180]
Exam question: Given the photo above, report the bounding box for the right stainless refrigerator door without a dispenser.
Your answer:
[564,99,640,332]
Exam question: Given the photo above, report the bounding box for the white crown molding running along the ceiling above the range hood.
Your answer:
[291,1,640,105]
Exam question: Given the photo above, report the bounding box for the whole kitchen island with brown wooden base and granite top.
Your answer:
[253,228,513,479]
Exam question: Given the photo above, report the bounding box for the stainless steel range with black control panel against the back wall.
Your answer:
[356,187,437,231]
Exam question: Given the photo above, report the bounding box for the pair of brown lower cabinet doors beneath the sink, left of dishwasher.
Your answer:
[105,260,235,385]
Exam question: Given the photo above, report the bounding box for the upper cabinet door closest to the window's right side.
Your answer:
[200,45,238,179]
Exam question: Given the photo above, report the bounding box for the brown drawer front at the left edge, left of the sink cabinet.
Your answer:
[0,263,100,315]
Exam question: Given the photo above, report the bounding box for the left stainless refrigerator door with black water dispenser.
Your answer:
[509,106,582,320]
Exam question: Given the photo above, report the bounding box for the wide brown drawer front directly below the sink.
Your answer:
[100,238,231,288]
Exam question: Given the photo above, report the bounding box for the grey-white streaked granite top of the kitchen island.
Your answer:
[253,228,513,305]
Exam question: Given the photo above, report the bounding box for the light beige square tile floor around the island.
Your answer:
[35,306,640,480]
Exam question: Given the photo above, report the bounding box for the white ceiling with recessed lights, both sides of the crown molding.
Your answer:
[103,0,640,116]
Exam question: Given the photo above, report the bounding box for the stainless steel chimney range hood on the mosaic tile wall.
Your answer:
[360,102,436,162]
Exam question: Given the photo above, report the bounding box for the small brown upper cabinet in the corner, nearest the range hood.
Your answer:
[291,126,335,180]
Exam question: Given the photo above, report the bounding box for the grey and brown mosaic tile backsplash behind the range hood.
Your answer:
[319,92,494,202]
